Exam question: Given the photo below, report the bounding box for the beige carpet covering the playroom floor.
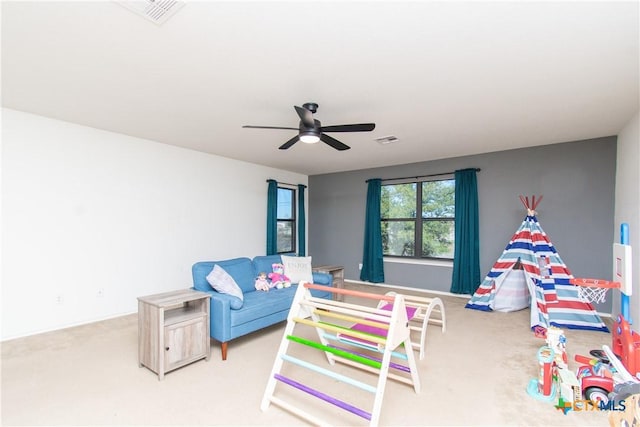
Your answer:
[1,289,611,426]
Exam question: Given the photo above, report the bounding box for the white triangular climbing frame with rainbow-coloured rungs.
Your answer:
[260,283,420,426]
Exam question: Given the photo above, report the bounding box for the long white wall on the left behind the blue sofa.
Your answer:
[1,109,308,340]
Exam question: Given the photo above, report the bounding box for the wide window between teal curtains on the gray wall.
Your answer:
[380,178,455,259]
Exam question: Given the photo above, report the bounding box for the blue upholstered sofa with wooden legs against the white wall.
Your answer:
[191,255,332,360]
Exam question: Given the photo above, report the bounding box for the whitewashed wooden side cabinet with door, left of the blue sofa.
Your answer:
[138,289,211,380]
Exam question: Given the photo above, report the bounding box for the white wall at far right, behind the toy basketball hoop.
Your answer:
[612,113,640,324]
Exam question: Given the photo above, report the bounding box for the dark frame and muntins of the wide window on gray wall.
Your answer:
[380,174,456,261]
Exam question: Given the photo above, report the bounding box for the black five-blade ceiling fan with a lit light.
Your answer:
[242,102,376,151]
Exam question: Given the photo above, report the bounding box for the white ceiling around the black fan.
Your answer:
[2,0,639,175]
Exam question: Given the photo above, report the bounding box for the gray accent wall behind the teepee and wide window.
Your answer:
[308,136,616,313]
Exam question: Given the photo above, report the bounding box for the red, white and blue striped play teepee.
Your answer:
[466,196,609,332]
